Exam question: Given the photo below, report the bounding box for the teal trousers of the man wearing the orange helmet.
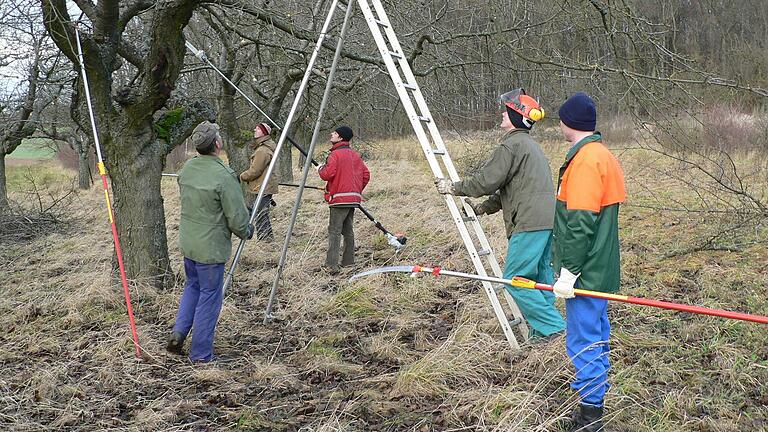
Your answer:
[504,230,565,338]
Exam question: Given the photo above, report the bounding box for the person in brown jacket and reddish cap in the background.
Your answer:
[240,123,278,242]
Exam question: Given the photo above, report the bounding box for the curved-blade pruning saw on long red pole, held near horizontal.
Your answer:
[350,266,768,324]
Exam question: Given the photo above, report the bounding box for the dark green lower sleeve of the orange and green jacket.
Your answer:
[557,210,599,274]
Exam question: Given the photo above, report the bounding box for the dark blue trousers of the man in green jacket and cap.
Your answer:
[173,258,224,362]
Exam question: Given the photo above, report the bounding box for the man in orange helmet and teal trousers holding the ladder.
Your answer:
[435,89,565,338]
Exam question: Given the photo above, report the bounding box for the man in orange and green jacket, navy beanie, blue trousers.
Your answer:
[553,93,626,432]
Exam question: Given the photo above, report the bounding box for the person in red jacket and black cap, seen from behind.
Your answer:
[317,126,371,274]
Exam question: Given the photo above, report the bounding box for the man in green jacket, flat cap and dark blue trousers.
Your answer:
[166,121,253,363]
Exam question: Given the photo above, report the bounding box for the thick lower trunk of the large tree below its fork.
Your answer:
[105,119,173,287]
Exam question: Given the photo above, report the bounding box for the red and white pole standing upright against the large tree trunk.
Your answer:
[75,25,141,359]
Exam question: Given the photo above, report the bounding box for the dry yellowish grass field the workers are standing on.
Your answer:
[0,133,768,432]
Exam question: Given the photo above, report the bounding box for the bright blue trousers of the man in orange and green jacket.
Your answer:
[565,296,611,406]
